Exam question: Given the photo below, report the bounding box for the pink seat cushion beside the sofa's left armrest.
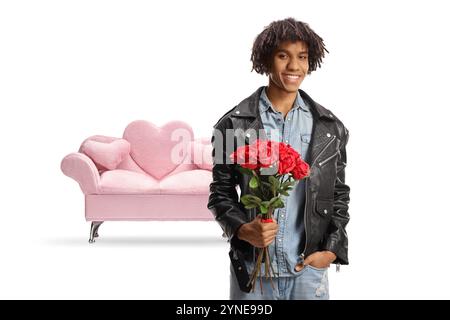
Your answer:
[99,169,160,194]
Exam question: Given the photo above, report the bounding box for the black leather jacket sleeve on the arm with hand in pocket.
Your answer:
[324,127,350,265]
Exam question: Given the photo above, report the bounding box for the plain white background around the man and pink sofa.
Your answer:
[0,0,450,299]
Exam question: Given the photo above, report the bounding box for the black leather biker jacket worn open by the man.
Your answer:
[208,87,350,288]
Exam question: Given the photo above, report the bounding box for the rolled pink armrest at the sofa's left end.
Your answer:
[61,152,100,194]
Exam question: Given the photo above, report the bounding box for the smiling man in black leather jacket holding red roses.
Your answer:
[208,18,350,299]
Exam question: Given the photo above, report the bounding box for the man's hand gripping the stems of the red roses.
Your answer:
[237,215,278,248]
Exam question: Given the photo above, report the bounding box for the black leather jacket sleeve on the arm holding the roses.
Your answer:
[208,125,248,247]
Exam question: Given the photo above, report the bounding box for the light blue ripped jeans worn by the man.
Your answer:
[230,265,329,300]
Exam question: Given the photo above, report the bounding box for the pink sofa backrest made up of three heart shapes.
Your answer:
[79,120,212,180]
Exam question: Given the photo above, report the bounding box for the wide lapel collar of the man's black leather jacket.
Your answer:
[231,86,336,121]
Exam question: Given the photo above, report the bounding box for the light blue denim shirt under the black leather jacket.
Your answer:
[247,87,313,277]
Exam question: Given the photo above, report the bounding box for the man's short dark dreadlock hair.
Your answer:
[250,18,328,75]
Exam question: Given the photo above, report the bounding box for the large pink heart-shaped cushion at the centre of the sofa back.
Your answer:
[123,120,194,180]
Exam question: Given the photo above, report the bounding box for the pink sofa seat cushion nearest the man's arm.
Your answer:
[159,169,212,194]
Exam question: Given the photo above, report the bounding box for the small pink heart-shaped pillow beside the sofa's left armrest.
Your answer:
[80,137,130,170]
